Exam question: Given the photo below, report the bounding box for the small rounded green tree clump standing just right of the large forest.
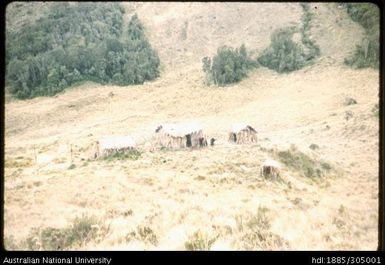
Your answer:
[202,45,257,86]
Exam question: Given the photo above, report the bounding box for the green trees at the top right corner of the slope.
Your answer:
[343,3,380,68]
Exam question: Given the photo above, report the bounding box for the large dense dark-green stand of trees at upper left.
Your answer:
[6,2,160,98]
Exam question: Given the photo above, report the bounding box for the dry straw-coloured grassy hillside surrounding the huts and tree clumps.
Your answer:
[4,2,379,250]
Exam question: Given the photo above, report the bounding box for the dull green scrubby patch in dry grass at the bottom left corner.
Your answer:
[18,215,109,250]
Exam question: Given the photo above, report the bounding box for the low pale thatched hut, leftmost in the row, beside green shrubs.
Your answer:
[92,136,136,158]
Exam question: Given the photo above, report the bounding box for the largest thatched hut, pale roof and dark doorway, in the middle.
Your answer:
[155,123,207,149]
